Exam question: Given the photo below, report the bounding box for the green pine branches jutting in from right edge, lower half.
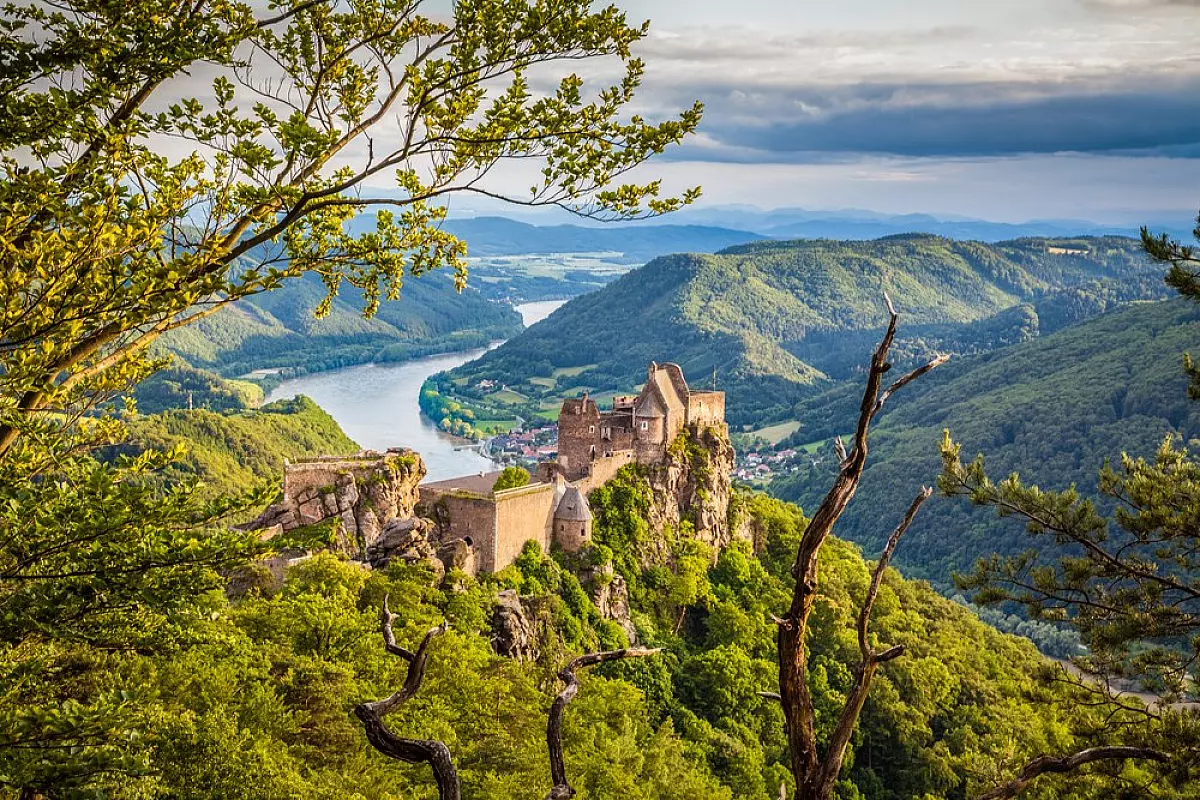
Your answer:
[938,433,1200,699]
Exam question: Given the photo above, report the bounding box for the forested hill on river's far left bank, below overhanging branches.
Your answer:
[157,271,521,377]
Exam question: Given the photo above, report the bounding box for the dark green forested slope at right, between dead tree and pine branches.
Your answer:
[772,300,1200,585]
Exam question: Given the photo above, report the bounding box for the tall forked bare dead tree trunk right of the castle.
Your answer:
[775,295,949,800]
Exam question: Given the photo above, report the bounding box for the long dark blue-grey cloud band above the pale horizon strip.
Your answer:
[678,82,1200,162]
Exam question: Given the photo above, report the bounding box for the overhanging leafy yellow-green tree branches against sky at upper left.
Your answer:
[0,0,701,455]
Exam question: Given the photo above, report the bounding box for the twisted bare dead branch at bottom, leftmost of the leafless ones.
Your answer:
[354,599,462,800]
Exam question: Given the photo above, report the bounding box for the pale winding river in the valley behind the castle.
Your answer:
[266,300,566,480]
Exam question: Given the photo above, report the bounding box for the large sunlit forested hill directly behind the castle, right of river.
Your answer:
[439,235,1164,425]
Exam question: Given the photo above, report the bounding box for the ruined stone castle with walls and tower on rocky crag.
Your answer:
[250,362,732,575]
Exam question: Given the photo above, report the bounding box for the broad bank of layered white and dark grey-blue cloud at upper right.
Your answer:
[614,12,1200,163]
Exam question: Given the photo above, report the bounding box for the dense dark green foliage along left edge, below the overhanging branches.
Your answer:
[0,452,265,796]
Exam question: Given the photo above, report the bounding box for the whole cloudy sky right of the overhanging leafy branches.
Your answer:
[549,0,1200,224]
